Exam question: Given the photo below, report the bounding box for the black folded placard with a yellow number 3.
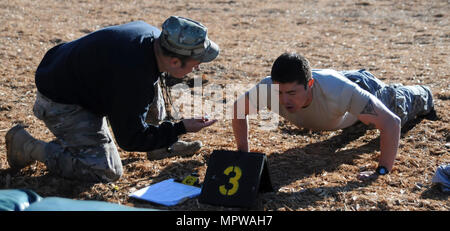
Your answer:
[199,150,273,207]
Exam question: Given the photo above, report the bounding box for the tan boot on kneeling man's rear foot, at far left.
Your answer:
[5,125,46,170]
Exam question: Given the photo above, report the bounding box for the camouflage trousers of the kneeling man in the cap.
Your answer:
[33,81,165,182]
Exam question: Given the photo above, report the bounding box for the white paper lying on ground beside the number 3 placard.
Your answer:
[130,179,201,206]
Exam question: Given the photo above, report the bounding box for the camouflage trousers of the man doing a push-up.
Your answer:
[341,69,434,126]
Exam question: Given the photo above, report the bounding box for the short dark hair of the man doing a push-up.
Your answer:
[271,53,312,89]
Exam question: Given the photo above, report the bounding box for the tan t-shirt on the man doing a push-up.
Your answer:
[248,69,370,130]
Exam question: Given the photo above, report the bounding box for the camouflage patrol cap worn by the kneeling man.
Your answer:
[160,16,219,63]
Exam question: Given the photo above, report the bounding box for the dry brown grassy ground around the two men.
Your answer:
[0,0,450,211]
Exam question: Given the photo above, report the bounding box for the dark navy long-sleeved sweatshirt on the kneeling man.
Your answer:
[35,21,186,151]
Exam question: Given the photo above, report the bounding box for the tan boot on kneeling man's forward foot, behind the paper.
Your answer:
[147,141,202,160]
